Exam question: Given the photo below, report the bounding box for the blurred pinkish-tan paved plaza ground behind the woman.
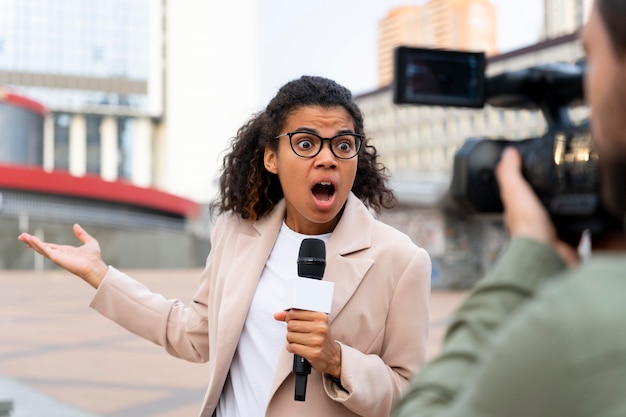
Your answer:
[0,269,465,417]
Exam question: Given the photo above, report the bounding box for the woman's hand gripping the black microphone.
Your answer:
[274,308,341,378]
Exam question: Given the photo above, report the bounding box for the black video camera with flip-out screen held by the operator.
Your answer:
[392,47,621,243]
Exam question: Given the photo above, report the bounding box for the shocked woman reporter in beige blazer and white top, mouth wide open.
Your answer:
[19,76,431,417]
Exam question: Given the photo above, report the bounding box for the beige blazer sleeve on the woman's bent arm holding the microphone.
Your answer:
[324,248,431,416]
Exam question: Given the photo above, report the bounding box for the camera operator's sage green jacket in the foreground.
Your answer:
[392,238,626,417]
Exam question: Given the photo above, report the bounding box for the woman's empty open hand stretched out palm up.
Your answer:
[17,224,108,288]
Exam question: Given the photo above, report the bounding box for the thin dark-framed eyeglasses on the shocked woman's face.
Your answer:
[275,132,363,159]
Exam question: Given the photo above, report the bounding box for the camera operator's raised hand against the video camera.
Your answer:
[495,148,578,265]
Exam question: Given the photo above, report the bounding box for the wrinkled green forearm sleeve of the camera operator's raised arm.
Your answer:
[393,238,565,417]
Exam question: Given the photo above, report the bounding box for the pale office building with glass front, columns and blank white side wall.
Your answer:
[0,0,259,203]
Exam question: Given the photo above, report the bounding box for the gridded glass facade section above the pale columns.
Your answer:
[0,0,150,111]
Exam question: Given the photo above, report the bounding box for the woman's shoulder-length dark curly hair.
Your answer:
[210,76,396,221]
